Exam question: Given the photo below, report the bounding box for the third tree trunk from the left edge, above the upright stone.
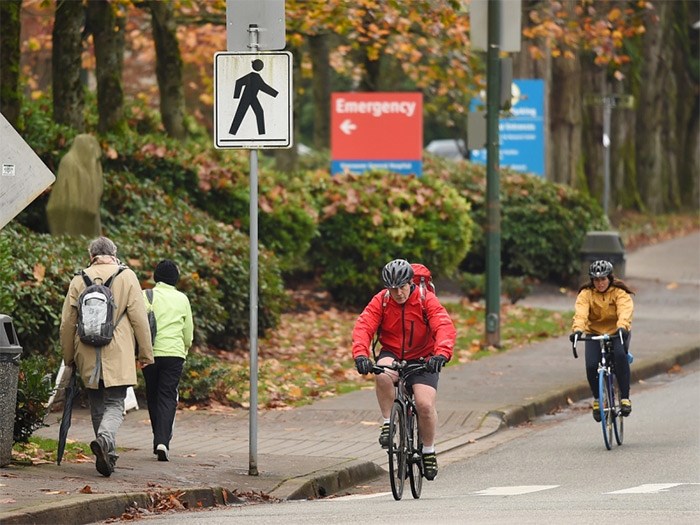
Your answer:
[87,0,126,133]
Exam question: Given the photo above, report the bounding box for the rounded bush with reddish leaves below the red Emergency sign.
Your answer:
[310,172,473,306]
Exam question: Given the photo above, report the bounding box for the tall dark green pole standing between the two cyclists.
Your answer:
[486,0,501,346]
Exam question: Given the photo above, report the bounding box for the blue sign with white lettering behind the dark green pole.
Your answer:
[470,79,545,177]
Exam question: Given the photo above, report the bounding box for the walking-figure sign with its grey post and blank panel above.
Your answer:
[223,0,294,476]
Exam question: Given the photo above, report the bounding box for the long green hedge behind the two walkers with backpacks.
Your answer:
[0,173,286,353]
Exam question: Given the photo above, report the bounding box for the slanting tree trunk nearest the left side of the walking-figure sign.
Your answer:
[148,1,187,139]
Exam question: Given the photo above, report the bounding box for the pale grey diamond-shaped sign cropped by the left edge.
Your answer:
[0,113,56,228]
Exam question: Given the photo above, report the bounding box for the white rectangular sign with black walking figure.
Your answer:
[214,51,293,149]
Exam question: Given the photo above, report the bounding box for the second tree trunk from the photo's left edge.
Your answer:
[51,0,85,131]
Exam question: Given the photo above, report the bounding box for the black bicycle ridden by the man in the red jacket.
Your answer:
[372,360,426,500]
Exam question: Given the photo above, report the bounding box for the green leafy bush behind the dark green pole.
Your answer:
[432,161,607,284]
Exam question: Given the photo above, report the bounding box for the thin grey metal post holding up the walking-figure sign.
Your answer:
[248,24,259,476]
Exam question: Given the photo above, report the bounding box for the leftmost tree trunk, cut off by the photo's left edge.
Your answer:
[0,0,22,128]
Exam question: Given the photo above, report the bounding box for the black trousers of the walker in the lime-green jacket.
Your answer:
[142,357,185,453]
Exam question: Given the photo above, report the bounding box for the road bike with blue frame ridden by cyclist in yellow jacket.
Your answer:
[572,334,625,450]
